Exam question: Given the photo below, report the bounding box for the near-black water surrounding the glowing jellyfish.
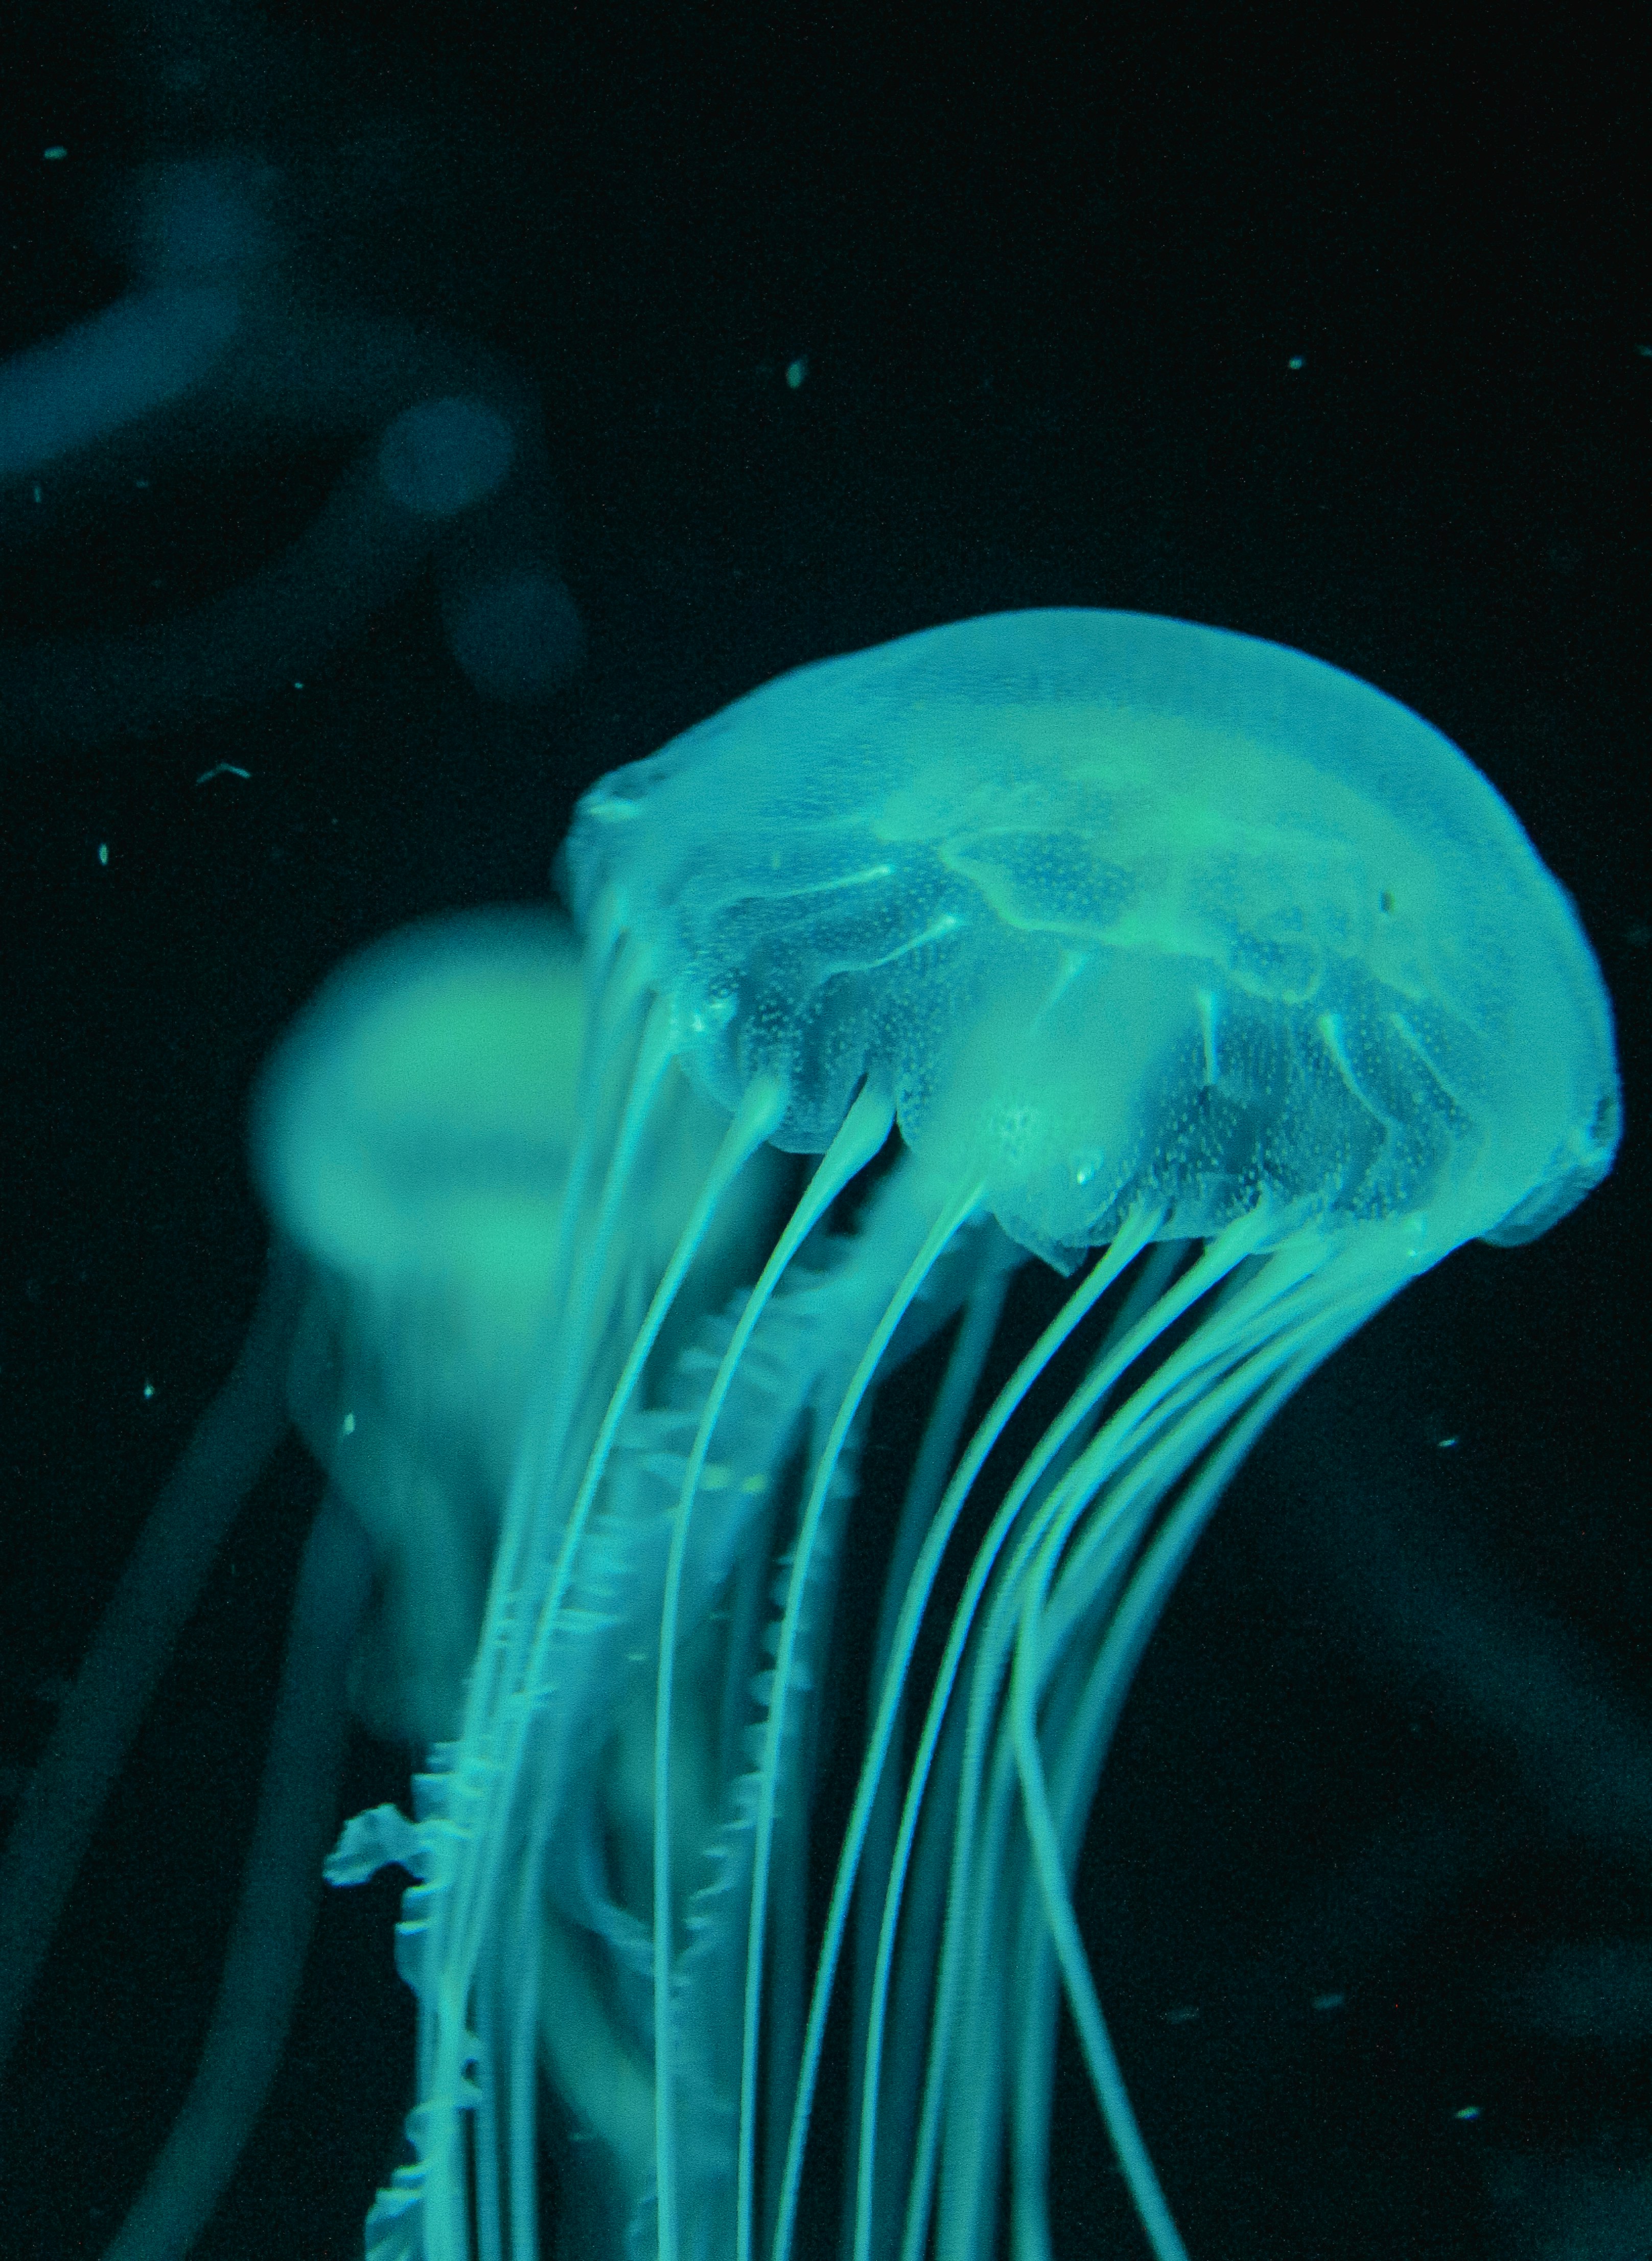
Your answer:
[0,0,1652,2261]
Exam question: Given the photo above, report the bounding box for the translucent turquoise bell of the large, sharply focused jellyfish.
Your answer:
[587,611,1616,1248]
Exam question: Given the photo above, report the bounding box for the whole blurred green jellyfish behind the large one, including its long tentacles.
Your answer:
[0,911,795,2261]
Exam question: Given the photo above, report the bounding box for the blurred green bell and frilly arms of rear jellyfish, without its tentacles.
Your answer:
[251,914,576,1745]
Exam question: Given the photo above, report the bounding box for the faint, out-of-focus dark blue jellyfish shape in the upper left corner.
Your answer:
[0,116,583,753]
